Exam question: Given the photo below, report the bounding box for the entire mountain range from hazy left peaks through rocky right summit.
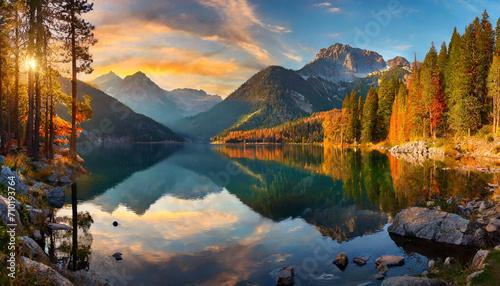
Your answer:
[81,43,411,141]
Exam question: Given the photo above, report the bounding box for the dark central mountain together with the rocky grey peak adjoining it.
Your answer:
[180,44,404,139]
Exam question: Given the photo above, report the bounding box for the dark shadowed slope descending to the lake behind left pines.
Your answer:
[56,78,183,142]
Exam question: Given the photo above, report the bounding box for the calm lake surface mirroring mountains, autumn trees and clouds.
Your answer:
[53,144,493,285]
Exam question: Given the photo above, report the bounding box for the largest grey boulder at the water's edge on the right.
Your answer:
[388,207,469,245]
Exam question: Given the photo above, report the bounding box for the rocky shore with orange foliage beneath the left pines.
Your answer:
[0,149,109,286]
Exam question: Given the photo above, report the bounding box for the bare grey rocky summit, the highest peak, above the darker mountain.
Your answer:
[298,43,386,82]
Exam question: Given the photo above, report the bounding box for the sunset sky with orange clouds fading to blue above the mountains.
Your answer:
[82,0,500,97]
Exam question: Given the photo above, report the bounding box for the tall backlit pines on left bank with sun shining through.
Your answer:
[0,0,96,161]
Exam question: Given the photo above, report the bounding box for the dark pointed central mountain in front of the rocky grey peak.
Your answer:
[178,66,335,139]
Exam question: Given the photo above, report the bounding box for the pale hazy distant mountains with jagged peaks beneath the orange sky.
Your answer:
[90,72,222,124]
